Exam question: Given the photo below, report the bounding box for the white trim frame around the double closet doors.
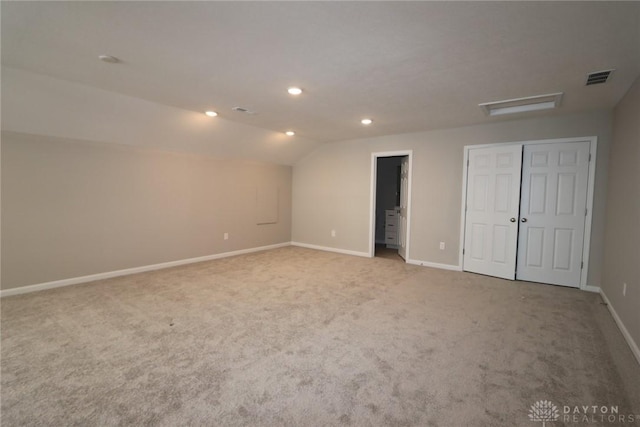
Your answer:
[458,136,598,291]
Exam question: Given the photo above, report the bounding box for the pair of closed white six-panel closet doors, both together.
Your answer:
[463,141,590,287]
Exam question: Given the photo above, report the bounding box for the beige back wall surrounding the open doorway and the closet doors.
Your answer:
[292,111,611,286]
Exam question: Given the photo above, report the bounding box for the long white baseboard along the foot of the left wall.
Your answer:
[0,242,291,298]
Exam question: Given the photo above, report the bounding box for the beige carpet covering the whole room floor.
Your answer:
[1,247,640,427]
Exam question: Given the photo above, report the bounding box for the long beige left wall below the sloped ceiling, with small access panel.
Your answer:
[1,132,291,289]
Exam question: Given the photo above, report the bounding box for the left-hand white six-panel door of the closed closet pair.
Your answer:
[463,145,522,280]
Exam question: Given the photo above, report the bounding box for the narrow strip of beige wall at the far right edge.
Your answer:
[602,78,640,361]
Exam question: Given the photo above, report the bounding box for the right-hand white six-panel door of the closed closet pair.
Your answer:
[516,141,590,287]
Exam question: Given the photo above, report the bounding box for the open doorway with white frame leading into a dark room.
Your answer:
[369,151,411,261]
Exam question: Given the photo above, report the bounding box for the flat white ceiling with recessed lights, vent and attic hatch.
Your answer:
[1,1,640,142]
